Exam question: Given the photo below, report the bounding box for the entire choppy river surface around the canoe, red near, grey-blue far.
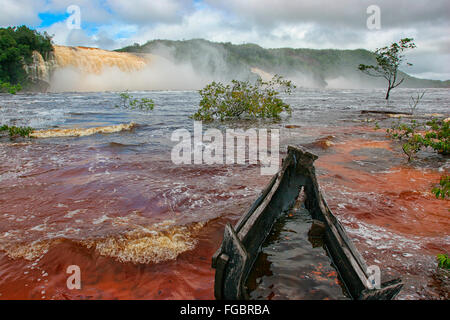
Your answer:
[0,89,450,299]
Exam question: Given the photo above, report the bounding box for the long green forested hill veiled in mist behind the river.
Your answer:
[116,39,450,88]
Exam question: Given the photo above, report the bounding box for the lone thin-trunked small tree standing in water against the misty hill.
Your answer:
[358,38,416,100]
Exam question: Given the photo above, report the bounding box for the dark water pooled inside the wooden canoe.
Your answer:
[245,208,351,300]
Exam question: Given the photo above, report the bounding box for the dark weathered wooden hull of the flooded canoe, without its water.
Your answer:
[212,146,403,300]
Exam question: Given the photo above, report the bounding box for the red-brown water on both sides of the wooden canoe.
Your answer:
[0,127,450,299]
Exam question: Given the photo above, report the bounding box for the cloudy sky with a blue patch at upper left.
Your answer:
[0,0,450,80]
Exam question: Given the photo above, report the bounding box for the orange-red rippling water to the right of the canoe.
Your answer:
[316,130,450,299]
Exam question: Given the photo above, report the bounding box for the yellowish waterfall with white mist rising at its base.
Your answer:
[49,46,207,92]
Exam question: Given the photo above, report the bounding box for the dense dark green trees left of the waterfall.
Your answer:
[0,26,53,87]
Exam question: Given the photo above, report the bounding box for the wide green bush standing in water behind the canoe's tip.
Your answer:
[192,75,295,121]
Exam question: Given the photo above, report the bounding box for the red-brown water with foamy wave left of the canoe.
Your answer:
[0,143,270,299]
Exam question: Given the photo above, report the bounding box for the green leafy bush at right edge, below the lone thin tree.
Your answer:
[386,119,450,161]
